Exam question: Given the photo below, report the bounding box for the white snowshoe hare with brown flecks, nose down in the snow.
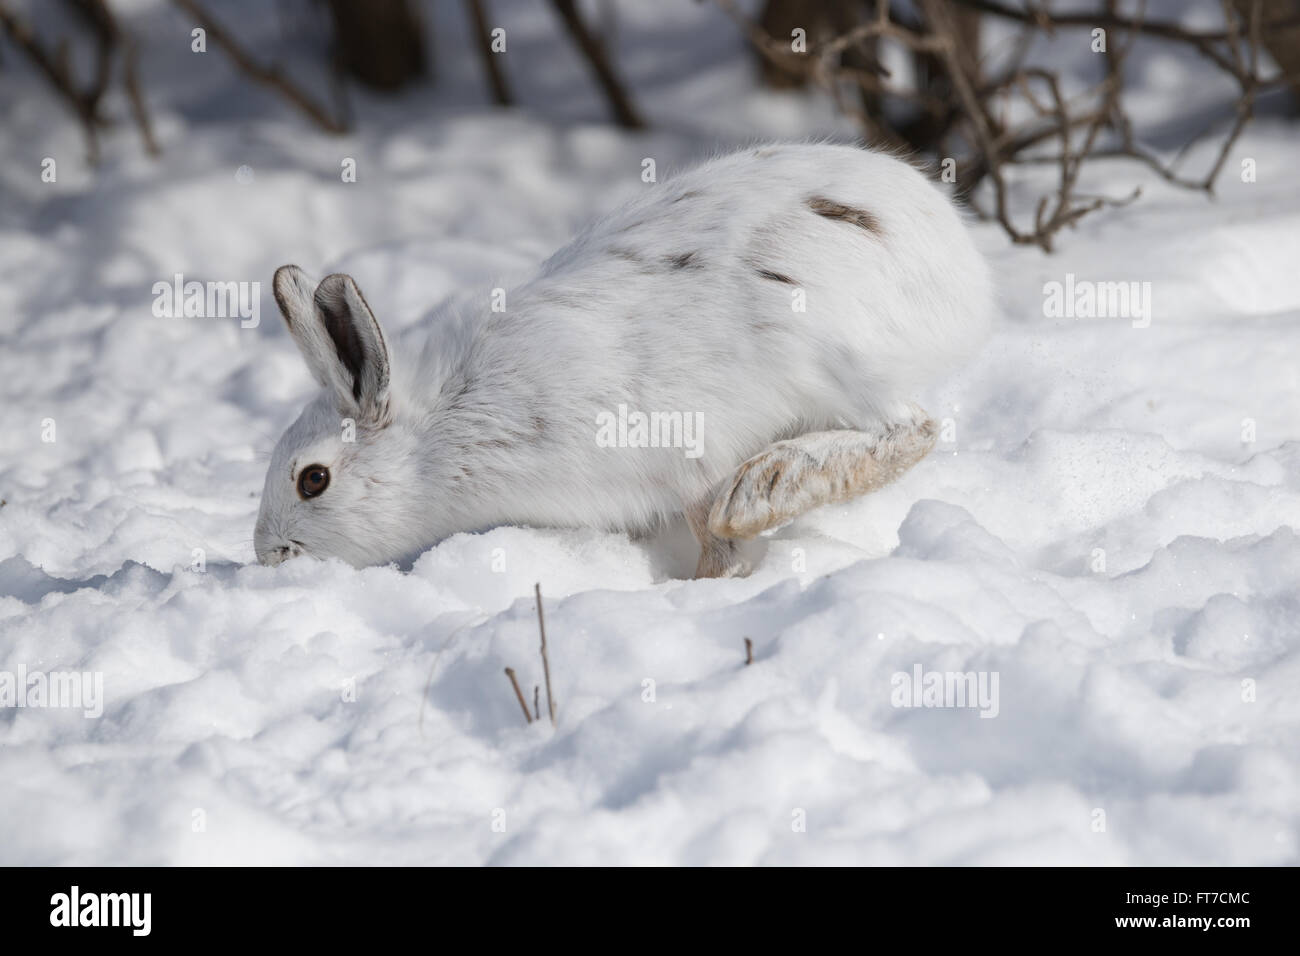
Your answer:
[255,144,993,576]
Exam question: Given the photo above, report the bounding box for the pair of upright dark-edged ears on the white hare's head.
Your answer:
[273,265,389,420]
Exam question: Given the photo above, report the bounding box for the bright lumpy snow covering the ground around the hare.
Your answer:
[0,0,1300,864]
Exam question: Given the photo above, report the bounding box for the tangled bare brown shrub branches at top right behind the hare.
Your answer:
[715,0,1268,251]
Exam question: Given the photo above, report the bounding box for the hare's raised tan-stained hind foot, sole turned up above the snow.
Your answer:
[693,406,937,546]
